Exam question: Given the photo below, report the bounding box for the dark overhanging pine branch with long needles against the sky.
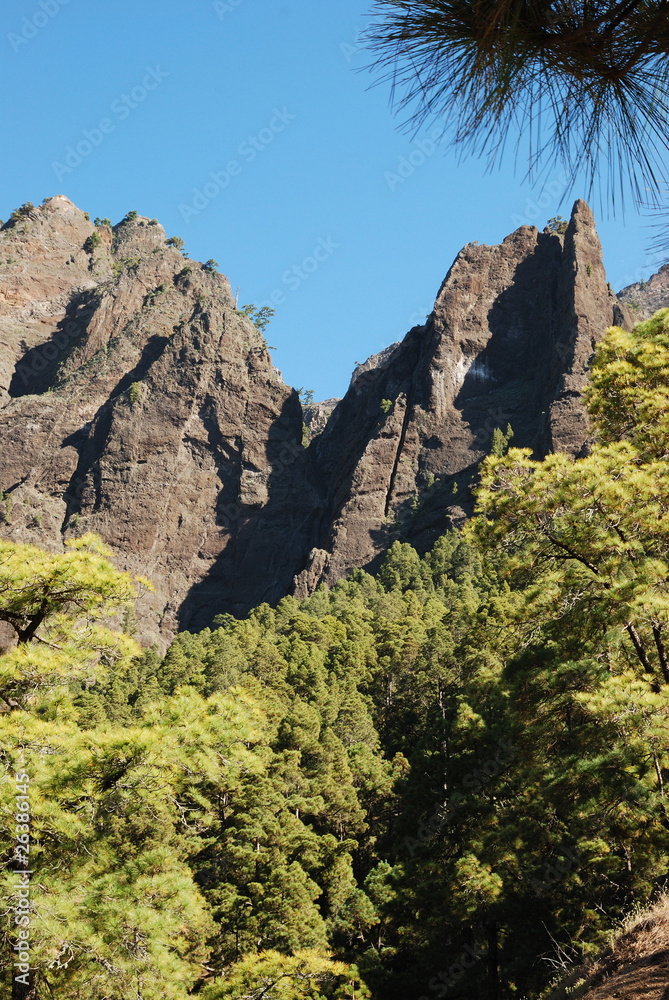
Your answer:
[366,0,669,216]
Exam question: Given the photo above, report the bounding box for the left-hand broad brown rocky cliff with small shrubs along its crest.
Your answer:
[0,198,318,640]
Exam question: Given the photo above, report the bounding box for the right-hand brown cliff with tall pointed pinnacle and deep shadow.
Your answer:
[295,201,632,595]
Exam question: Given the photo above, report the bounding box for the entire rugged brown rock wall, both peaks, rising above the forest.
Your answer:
[0,197,630,646]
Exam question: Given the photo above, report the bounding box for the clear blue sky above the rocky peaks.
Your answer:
[0,0,656,399]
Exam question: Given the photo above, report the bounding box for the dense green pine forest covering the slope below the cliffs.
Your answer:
[0,310,669,1000]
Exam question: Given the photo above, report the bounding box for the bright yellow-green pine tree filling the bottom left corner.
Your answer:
[0,690,261,1000]
